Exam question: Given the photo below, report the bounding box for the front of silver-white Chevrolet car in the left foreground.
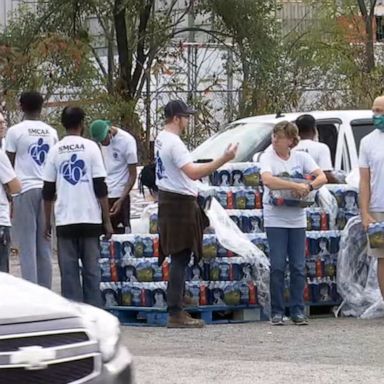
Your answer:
[0,273,133,384]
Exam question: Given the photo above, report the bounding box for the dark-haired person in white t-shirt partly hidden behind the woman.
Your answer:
[293,114,339,183]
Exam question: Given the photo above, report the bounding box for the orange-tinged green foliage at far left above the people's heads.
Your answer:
[0,3,98,133]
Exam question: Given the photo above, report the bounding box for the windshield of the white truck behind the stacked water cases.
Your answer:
[192,122,273,162]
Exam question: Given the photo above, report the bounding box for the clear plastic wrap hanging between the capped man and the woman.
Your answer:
[206,198,270,312]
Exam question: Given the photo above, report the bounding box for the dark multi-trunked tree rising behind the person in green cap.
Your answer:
[23,0,198,158]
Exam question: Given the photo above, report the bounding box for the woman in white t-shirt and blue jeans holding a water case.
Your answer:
[261,121,327,325]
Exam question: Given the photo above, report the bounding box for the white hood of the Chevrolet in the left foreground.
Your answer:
[0,272,79,324]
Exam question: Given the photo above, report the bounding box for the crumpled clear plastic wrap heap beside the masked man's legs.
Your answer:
[337,216,384,319]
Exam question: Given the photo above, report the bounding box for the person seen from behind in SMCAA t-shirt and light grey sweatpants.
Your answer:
[5,92,58,288]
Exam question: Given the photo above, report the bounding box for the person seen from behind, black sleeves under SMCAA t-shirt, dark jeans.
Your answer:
[43,107,113,306]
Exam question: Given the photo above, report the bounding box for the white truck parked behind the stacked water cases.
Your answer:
[192,110,374,173]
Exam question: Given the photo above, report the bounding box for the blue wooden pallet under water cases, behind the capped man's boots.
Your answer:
[105,305,267,326]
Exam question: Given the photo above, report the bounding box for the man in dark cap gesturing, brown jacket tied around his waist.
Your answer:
[155,100,237,328]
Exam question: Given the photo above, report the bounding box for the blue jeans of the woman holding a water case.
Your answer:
[266,227,305,316]
